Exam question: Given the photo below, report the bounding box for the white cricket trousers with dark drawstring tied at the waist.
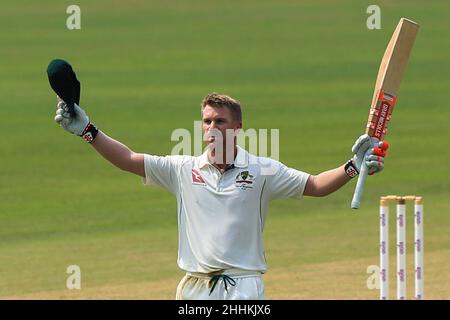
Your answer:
[176,269,265,300]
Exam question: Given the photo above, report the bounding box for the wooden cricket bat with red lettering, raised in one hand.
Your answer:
[351,18,419,209]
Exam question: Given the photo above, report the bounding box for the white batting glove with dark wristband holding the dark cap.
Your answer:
[55,97,98,143]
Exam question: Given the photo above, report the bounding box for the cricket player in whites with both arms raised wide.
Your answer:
[55,93,387,300]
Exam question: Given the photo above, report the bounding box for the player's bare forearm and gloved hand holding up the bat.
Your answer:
[303,134,389,197]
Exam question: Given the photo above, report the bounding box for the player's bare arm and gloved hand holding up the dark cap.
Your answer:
[55,99,145,177]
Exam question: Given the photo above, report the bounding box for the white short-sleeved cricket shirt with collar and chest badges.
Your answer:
[144,146,309,273]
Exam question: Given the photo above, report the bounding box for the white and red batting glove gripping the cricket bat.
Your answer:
[346,134,389,178]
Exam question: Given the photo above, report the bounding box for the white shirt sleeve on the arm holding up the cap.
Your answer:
[143,154,183,193]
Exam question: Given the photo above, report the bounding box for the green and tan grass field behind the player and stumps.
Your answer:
[0,0,450,299]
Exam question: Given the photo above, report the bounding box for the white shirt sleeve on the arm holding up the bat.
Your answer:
[267,162,310,199]
